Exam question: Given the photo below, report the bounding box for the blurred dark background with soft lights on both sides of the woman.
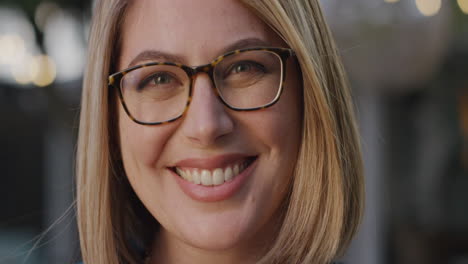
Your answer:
[0,0,468,264]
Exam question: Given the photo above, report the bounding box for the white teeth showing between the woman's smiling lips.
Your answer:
[170,157,257,186]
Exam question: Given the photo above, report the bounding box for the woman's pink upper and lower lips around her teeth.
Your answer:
[169,154,256,202]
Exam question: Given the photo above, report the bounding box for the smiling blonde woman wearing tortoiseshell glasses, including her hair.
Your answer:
[77,0,363,264]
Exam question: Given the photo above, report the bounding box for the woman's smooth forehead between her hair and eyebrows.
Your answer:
[119,0,282,68]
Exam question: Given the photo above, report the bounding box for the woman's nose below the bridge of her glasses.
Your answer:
[181,73,234,147]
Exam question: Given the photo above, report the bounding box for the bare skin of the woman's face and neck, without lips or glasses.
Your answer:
[118,0,301,263]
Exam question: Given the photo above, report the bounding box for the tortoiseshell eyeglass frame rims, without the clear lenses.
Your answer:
[108,47,295,125]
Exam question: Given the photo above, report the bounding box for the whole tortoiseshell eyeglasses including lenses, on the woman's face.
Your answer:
[109,47,294,125]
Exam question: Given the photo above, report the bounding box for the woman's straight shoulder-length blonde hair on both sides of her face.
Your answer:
[77,0,364,264]
